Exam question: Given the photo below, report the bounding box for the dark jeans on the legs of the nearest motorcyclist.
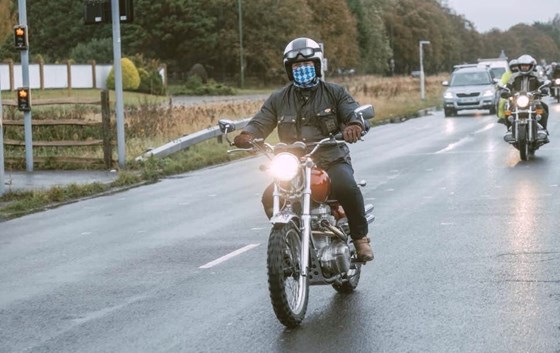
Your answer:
[262,162,368,239]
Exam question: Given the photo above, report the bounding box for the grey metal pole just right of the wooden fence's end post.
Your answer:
[111,0,126,168]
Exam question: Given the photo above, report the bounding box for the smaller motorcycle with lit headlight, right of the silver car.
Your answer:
[501,80,550,161]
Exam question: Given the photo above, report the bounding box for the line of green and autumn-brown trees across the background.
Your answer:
[0,0,560,82]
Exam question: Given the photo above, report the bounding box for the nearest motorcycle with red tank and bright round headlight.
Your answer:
[218,105,375,328]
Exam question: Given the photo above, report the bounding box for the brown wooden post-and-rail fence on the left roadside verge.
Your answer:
[2,90,113,169]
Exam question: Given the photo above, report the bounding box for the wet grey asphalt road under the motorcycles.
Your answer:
[0,100,560,353]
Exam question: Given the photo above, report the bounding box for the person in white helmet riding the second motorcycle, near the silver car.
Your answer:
[500,54,549,143]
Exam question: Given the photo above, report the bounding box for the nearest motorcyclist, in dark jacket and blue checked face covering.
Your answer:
[234,38,373,261]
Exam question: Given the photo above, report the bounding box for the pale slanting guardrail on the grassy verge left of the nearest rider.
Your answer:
[135,118,251,161]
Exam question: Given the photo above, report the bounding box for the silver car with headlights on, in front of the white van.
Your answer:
[442,67,500,117]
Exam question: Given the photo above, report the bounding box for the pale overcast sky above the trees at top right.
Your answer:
[447,0,560,33]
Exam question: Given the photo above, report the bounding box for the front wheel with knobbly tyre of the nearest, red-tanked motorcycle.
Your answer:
[267,223,309,327]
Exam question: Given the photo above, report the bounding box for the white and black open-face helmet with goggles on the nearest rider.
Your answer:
[284,38,323,81]
